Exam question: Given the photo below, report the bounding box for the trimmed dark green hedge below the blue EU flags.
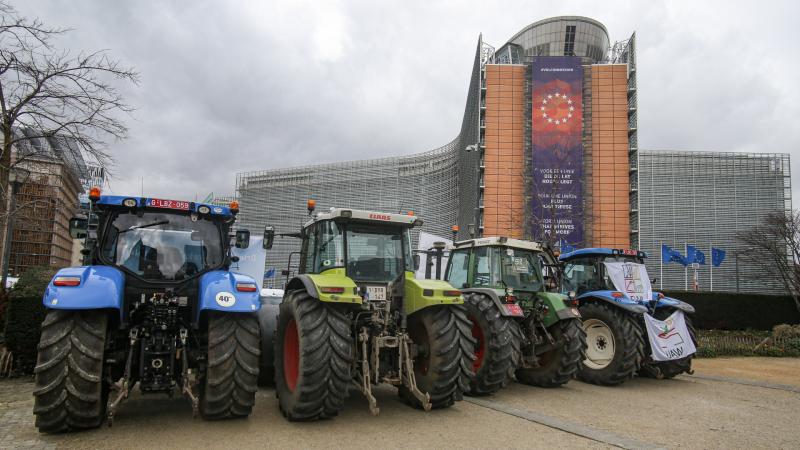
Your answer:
[664,291,800,330]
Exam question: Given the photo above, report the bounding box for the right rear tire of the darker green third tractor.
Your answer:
[515,319,586,387]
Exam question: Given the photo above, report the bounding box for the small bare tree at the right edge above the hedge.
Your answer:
[737,210,800,311]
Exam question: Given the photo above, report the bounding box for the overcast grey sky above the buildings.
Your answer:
[12,0,800,204]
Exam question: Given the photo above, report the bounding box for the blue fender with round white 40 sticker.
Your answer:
[197,270,261,318]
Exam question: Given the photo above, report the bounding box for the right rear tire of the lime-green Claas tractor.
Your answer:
[399,305,475,409]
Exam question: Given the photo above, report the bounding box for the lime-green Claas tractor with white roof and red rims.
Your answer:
[264,206,473,421]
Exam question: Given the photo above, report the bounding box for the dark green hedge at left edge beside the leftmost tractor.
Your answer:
[5,267,54,375]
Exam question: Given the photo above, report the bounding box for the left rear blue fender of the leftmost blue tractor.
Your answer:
[42,266,125,312]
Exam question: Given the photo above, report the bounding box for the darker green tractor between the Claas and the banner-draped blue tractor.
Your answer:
[446,237,586,395]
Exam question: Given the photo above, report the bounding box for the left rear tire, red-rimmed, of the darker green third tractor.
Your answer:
[464,294,516,395]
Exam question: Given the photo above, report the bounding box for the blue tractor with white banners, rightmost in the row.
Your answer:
[559,248,695,386]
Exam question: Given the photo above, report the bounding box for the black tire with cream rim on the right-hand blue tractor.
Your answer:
[578,301,644,386]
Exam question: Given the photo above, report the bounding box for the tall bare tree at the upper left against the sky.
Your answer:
[0,2,138,207]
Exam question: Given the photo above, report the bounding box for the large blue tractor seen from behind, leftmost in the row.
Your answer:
[33,188,260,432]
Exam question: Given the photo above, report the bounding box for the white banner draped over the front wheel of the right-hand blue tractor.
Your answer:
[644,310,697,361]
